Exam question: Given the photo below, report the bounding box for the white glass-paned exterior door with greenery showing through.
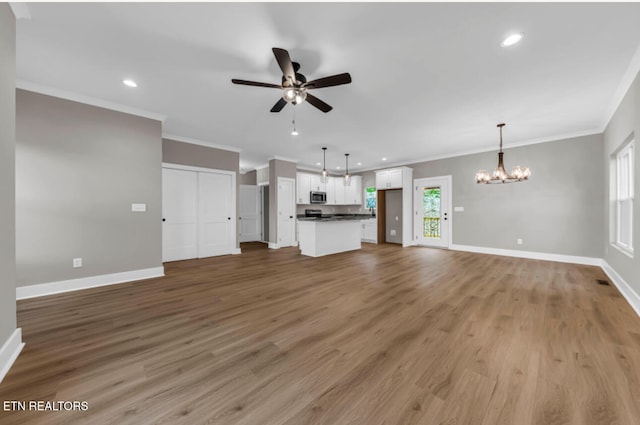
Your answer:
[413,176,451,248]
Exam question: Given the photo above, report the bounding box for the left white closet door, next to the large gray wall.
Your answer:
[162,168,198,261]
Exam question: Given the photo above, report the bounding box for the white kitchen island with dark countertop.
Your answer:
[298,214,372,257]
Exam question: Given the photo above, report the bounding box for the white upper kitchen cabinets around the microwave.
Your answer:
[296,173,362,205]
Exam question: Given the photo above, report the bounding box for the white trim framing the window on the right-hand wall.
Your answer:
[611,141,635,258]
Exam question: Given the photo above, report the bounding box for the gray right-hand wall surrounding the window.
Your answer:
[602,69,640,294]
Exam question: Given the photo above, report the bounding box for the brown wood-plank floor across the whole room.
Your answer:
[0,244,640,425]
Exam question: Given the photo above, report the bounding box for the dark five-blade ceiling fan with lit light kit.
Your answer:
[231,47,351,112]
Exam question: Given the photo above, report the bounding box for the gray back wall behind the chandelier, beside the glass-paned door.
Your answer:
[408,135,605,258]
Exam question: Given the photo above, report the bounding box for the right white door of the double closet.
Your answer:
[198,172,235,258]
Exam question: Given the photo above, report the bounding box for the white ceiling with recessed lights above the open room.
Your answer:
[17,3,640,171]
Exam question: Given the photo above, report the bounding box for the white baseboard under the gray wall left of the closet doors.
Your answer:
[16,267,164,300]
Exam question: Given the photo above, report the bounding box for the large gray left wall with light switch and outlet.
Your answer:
[16,90,162,286]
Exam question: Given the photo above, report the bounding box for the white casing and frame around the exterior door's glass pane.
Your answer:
[413,176,452,248]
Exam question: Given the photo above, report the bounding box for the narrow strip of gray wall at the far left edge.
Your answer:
[0,3,16,347]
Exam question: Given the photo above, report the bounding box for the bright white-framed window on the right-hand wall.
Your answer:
[615,140,634,255]
